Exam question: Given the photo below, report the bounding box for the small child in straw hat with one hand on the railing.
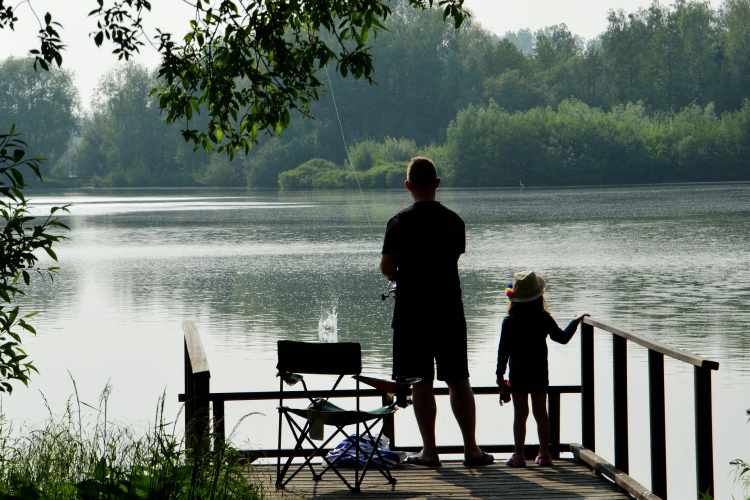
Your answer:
[497,271,589,467]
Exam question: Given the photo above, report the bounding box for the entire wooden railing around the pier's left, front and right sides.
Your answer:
[179,318,719,500]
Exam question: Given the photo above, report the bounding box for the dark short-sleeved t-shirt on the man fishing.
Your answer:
[382,201,466,328]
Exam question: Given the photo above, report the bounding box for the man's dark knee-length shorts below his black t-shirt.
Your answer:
[393,321,469,382]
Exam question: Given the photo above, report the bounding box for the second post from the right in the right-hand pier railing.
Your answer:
[648,349,667,500]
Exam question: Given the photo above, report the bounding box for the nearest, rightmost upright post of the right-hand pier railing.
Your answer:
[694,366,716,498]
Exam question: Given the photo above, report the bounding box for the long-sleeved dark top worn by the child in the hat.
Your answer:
[496,312,581,392]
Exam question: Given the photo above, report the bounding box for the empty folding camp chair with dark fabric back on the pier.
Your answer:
[276,340,409,492]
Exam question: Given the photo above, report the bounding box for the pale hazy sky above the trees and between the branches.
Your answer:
[0,0,688,108]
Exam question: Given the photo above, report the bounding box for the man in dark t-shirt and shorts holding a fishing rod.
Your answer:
[380,158,493,467]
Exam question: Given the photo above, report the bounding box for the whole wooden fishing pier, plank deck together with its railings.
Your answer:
[179,318,719,500]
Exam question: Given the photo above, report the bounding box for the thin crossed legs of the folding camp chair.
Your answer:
[276,413,396,492]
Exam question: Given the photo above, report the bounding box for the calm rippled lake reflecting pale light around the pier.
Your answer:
[2,184,750,498]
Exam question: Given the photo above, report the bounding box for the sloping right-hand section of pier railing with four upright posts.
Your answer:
[581,318,719,500]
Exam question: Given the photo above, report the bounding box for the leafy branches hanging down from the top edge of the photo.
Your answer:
[0,0,468,158]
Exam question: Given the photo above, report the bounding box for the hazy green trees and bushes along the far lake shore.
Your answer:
[0,0,750,189]
